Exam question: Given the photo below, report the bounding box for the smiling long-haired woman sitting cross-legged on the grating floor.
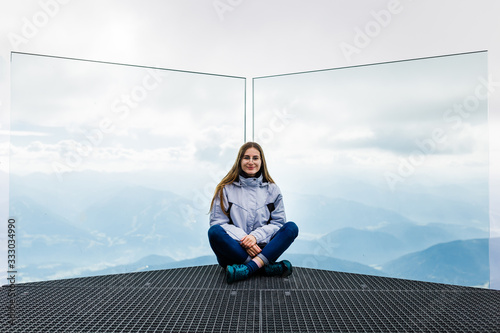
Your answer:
[208,142,299,283]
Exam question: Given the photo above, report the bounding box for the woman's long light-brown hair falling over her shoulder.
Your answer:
[210,142,274,215]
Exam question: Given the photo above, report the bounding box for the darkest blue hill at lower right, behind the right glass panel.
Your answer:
[382,239,490,286]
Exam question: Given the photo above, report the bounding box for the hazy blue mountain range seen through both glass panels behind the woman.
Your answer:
[10,173,489,284]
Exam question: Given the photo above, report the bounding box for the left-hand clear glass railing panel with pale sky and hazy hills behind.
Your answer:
[10,53,245,282]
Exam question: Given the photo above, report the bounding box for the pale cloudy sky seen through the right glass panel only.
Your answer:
[255,53,489,183]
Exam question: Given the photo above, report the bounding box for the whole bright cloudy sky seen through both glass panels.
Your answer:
[11,52,488,196]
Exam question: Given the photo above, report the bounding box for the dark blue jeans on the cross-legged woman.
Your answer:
[208,222,299,268]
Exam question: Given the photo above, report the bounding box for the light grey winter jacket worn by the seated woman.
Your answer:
[210,175,286,244]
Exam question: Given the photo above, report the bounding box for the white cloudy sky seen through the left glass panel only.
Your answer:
[11,54,245,178]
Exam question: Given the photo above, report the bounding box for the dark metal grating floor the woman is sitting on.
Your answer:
[0,265,500,333]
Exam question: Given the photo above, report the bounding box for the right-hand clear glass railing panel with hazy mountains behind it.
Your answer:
[253,52,489,286]
